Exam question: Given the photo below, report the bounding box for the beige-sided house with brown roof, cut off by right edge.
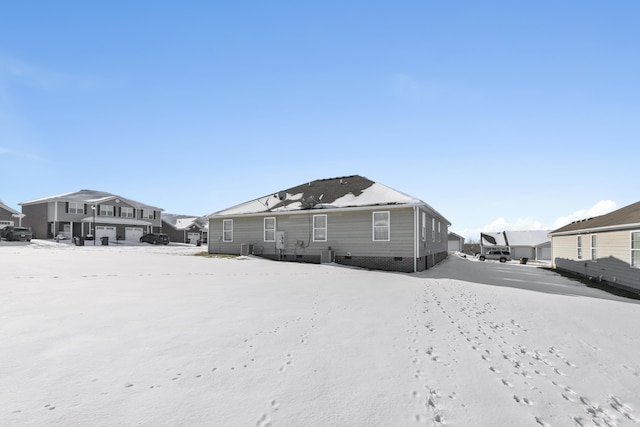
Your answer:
[549,202,640,293]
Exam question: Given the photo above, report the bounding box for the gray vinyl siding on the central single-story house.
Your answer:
[209,207,448,271]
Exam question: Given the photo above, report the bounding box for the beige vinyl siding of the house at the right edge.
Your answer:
[552,230,640,291]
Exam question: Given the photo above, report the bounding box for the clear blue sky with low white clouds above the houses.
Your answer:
[0,0,640,239]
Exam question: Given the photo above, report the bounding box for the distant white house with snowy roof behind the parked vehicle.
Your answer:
[480,230,551,261]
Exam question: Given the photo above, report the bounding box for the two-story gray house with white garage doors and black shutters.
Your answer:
[20,190,162,242]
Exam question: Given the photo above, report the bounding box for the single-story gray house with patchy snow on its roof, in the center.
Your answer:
[208,175,451,272]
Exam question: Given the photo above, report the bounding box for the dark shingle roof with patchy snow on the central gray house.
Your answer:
[210,175,448,222]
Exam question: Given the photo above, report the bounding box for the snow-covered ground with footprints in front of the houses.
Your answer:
[0,241,640,427]
